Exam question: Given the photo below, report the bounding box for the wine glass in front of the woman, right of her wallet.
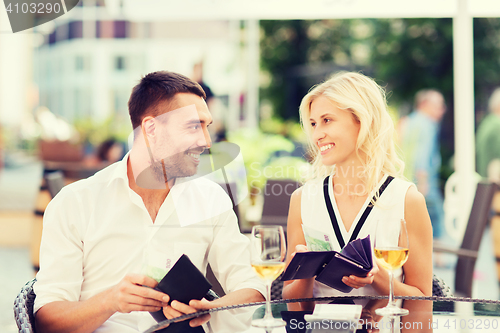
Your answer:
[374,219,409,316]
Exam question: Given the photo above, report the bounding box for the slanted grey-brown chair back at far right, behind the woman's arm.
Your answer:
[455,182,497,297]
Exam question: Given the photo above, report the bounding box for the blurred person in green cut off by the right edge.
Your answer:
[476,88,500,182]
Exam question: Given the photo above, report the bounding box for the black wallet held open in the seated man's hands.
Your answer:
[150,254,212,322]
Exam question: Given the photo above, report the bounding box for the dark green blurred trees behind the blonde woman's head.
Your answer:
[261,18,458,119]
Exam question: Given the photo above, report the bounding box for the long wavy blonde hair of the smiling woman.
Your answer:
[300,72,404,193]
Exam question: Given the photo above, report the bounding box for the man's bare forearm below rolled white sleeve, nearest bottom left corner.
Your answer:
[35,291,114,333]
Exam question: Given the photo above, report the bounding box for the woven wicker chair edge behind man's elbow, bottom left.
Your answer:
[14,279,36,333]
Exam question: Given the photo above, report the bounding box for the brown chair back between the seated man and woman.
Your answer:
[260,179,300,230]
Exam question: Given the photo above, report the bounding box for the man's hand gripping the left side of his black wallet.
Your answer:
[106,274,170,313]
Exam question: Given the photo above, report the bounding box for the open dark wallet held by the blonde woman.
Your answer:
[281,235,373,293]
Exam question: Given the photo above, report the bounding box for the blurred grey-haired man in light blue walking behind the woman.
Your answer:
[400,89,446,239]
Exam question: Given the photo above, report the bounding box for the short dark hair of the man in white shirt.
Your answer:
[128,71,206,129]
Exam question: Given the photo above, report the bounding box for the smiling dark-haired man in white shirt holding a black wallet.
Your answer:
[35,72,263,332]
